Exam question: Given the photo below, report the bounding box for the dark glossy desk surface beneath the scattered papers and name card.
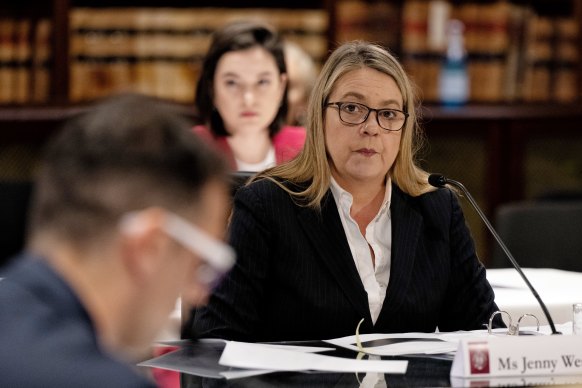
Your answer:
[149,342,582,388]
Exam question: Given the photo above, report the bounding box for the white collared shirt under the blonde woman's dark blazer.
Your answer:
[331,177,392,324]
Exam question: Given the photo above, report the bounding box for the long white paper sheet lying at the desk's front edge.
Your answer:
[218,341,408,374]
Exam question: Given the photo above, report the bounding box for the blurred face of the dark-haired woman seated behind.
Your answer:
[213,46,286,135]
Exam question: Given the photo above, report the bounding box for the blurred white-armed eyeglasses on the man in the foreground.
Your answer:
[120,211,236,287]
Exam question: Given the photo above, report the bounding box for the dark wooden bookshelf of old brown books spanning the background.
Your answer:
[0,0,582,106]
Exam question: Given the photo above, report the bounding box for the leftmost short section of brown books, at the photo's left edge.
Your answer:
[0,18,51,104]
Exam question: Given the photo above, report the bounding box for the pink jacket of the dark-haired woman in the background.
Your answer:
[194,125,306,169]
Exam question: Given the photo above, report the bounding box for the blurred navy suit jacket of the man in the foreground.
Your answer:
[0,256,154,388]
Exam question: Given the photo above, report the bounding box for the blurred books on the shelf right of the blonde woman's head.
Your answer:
[402,0,580,103]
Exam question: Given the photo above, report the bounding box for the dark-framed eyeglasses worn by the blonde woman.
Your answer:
[325,102,408,131]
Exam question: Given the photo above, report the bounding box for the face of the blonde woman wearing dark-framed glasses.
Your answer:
[324,67,403,189]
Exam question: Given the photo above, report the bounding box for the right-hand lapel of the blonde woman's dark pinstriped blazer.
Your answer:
[376,185,423,326]
